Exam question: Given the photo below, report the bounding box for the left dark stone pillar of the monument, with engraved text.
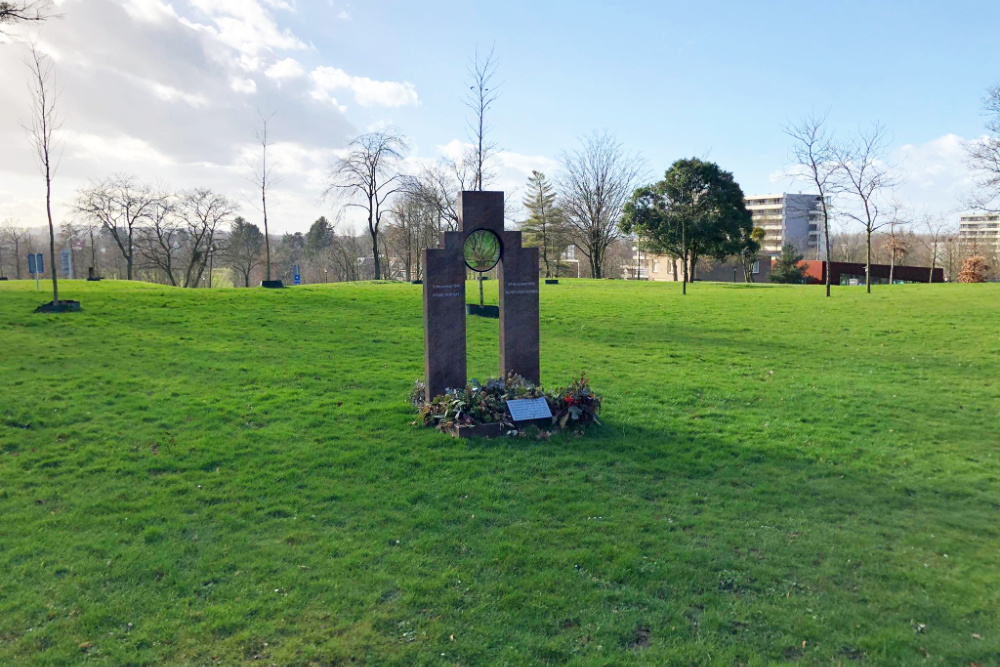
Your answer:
[424,239,468,400]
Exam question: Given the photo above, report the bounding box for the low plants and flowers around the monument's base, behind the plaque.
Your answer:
[410,373,601,430]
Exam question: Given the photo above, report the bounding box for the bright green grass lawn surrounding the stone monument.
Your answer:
[0,281,1000,666]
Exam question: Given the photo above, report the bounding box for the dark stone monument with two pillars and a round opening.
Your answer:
[423,191,541,400]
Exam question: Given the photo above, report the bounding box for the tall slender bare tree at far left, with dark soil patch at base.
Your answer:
[28,45,60,306]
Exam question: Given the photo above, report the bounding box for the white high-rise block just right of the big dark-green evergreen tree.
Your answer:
[744,194,825,259]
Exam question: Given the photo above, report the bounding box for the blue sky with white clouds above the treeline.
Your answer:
[0,0,1000,233]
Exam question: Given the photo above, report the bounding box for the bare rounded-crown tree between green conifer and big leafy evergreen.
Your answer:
[557,132,642,278]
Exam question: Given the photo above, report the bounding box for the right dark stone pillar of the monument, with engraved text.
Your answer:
[498,232,541,385]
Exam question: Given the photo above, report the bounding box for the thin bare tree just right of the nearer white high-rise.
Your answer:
[785,114,841,297]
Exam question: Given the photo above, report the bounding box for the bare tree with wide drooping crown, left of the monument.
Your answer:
[323,129,409,280]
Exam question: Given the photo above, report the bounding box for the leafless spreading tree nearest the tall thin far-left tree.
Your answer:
[75,174,157,280]
